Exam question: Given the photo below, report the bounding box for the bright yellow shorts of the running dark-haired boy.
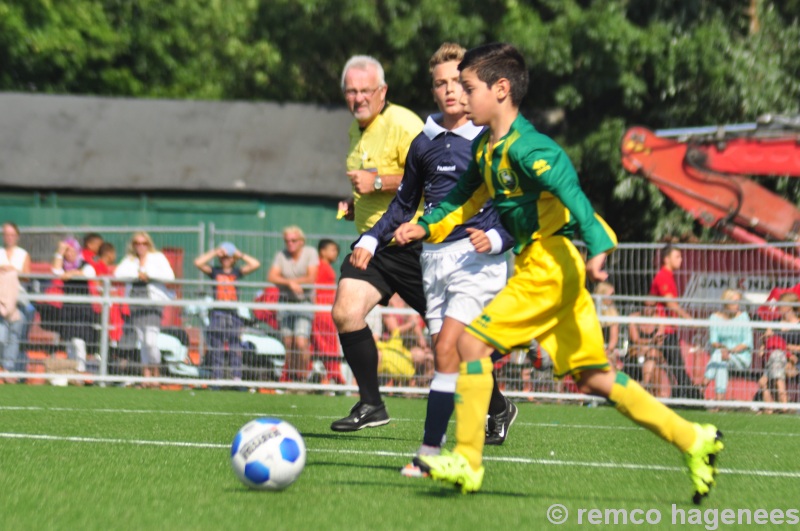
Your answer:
[467,236,610,378]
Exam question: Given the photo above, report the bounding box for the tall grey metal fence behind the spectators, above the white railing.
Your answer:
[20,223,800,302]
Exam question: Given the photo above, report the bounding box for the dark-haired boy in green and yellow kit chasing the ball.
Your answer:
[395,43,723,503]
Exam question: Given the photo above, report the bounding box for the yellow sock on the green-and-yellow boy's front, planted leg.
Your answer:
[455,357,494,470]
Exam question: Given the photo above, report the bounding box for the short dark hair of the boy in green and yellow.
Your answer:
[458,42,528,107]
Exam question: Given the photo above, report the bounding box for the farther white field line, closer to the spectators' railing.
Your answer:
[0,406,800,437]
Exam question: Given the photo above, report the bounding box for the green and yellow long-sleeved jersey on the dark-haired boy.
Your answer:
[419,115,617,258]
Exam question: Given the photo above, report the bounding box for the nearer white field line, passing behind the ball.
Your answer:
[0,432,800,479]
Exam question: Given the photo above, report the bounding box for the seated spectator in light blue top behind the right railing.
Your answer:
[703,289,753,406]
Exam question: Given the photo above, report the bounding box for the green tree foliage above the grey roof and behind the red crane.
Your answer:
[0,0,800,241]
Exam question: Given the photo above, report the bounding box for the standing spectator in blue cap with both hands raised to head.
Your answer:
[194,242,261,380]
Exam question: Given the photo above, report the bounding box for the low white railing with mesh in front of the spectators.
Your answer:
[0,277,800,409]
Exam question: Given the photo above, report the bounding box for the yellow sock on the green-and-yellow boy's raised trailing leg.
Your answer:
[608,372,696,452]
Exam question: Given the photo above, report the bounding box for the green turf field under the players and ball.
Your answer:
[0,385,800,530]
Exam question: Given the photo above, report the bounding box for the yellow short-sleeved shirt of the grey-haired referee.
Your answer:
[347,103,423,234]
